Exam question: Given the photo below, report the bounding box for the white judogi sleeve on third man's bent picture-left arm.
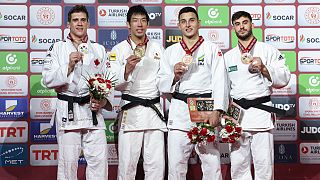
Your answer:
[158,47,175,93]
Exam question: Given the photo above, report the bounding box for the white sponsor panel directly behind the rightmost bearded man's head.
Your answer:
[230,6,263,27]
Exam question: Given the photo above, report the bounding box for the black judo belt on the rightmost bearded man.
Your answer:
[233,96,286,115]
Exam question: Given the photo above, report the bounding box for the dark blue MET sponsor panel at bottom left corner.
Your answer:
[0,144,28,166]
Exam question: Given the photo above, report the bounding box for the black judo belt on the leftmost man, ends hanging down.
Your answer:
[57,94,98,125]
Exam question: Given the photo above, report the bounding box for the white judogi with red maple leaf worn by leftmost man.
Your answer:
[42,39,112,180]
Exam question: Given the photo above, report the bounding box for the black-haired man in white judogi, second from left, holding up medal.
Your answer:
[110,5,167,180]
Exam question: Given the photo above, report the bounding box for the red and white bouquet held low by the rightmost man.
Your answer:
[219,115,242,143]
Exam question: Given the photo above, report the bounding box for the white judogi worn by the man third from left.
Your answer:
[159,41,229,180]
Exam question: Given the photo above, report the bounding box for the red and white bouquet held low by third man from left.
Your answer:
[187,122,216,145]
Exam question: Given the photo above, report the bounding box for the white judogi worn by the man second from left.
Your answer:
[110,40,167,180]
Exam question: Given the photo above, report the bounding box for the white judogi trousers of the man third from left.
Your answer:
[168,130,222,180]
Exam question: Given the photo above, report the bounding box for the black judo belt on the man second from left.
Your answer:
[121,94,166,121]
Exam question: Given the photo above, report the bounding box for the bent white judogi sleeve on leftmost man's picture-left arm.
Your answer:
[42,42,72,89]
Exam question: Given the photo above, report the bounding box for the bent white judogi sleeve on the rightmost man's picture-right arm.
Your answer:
[265,48,291,88]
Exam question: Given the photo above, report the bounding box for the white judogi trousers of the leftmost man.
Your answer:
[57,129,108,180]
